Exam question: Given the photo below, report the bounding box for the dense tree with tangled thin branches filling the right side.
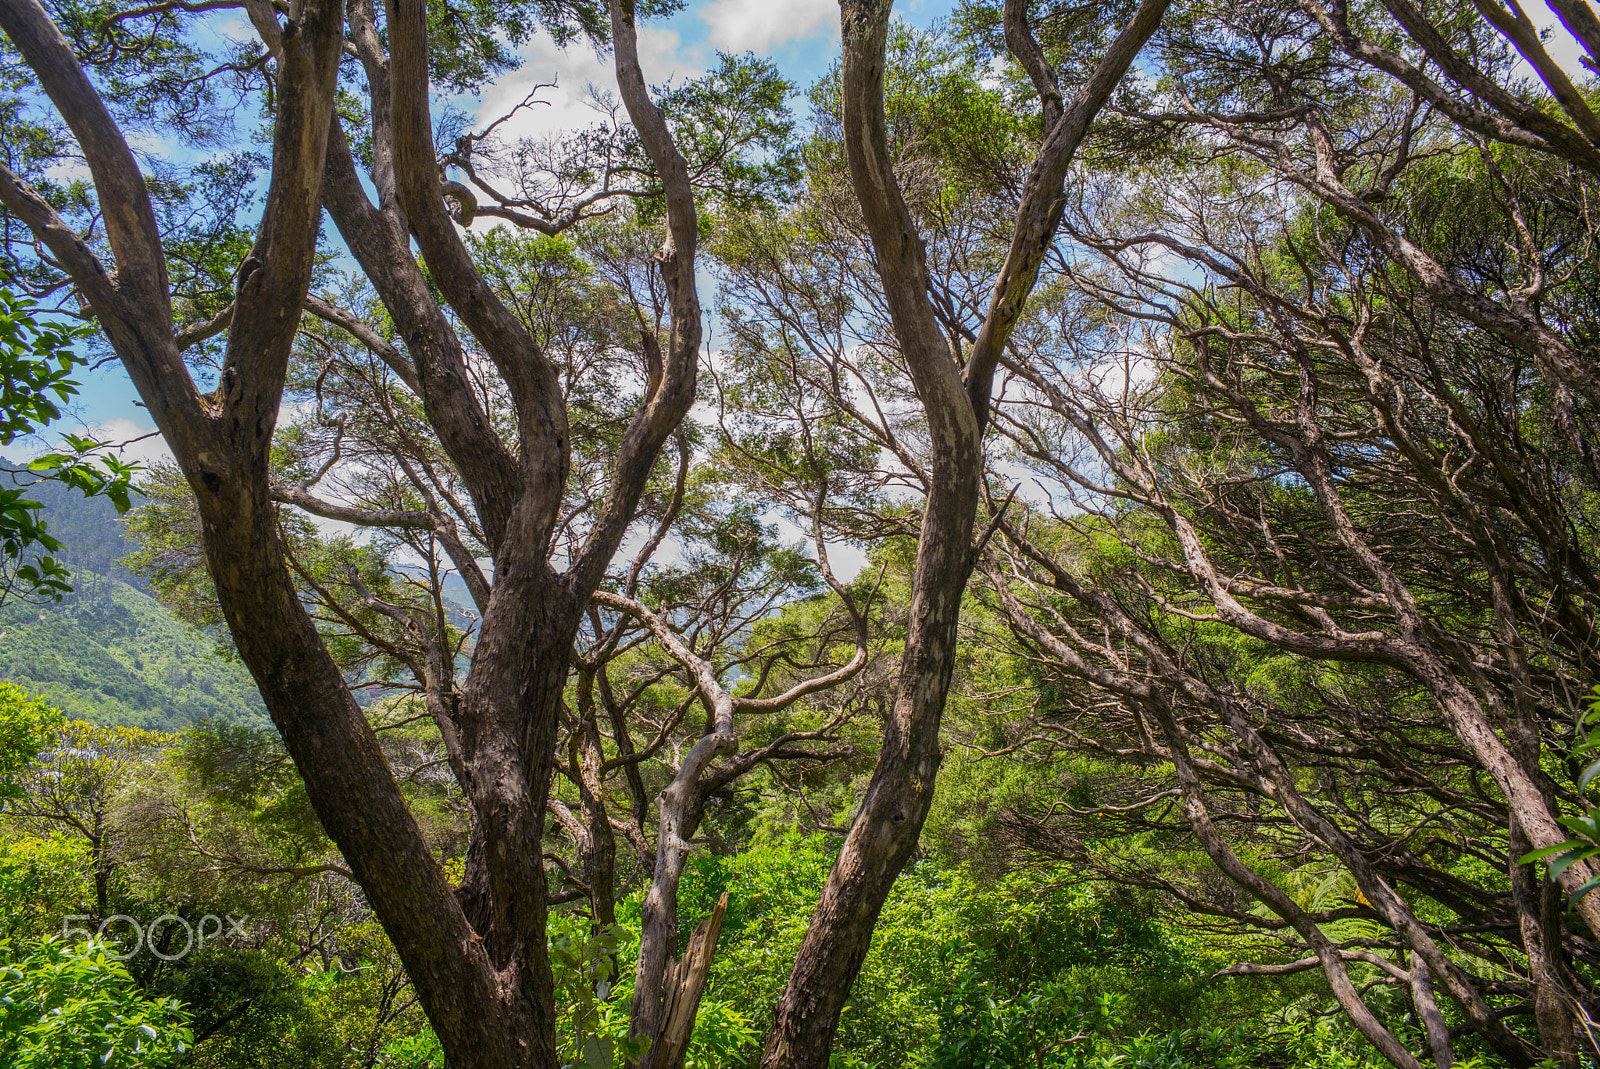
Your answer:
[953,5,1600,1066]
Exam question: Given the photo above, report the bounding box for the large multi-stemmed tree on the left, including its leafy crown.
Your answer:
[0,0,859,1066]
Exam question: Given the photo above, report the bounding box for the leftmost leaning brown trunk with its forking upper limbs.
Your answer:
[0,0,547,1066]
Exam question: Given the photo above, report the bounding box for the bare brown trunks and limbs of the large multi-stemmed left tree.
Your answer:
[0,0,713,1069]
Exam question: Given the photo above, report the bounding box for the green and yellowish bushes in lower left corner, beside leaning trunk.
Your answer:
[0,688,454,1069]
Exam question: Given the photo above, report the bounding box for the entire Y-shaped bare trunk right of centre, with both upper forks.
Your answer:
[762,0,1166,1069]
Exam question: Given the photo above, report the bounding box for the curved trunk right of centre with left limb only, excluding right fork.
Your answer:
[762,0,982,1069]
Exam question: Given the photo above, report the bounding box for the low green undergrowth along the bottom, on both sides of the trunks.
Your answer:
[0,672,1408,1069]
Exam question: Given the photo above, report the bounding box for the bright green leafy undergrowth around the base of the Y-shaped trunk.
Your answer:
[662,827,1401,1069]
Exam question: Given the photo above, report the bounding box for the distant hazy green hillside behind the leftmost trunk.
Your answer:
[0,461,267,731]
